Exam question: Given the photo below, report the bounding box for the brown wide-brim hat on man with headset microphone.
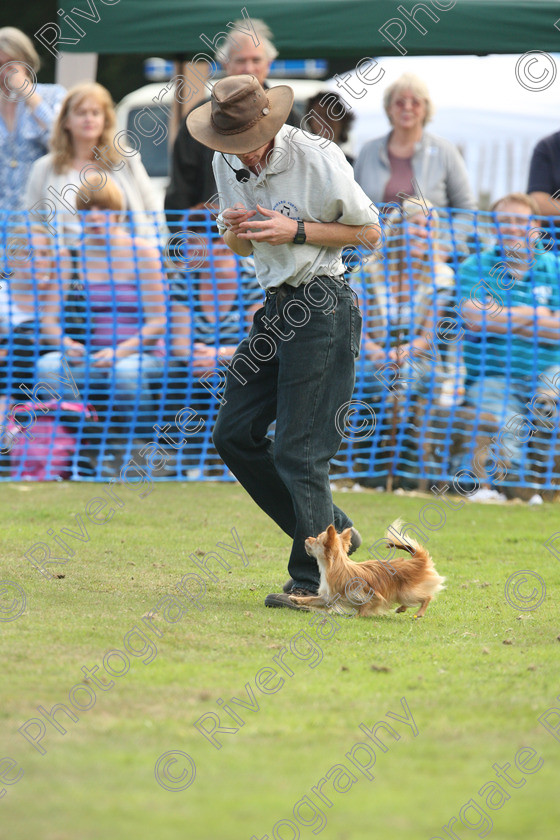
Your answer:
[187,76,294,155]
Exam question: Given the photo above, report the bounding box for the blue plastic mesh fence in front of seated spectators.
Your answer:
[0,204,560,489]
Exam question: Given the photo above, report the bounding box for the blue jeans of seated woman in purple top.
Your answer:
[37,351,163,437]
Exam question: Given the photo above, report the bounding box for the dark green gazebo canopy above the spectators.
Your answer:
[55,0,560,62]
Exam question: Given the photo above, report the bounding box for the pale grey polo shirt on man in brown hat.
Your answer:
[212,125,379,289]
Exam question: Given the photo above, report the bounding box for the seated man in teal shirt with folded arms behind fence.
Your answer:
[459,193,560,492]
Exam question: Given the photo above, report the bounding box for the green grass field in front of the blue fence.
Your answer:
[0,483,560,840]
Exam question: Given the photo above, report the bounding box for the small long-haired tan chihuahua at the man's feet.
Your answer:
[290,519,445,618]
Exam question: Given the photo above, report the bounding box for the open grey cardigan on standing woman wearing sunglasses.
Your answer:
[354,131,476,210]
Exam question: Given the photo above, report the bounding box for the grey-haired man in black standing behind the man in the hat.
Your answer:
[165,19,300,220]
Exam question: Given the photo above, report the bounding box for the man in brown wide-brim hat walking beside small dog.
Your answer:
[187,75,380,608]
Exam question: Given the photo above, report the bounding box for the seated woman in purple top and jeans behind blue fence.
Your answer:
[35,181,165,438]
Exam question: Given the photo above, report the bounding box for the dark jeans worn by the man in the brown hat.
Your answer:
[214,277,361,591]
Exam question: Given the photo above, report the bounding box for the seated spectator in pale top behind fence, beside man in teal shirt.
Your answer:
[356,201,459,482]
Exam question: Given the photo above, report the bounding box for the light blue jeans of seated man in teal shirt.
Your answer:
[463,365,560,476]
